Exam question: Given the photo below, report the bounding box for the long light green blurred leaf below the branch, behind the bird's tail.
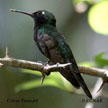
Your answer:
[15,70,72,92]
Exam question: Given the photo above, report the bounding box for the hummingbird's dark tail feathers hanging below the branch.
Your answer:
[60,65,92,98]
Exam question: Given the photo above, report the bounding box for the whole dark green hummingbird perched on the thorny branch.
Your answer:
[11,9,92,98]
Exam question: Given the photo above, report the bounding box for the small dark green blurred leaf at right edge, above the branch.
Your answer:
[95,52,108,67]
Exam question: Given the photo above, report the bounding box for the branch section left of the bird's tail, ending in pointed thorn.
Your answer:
[0,57,71,73]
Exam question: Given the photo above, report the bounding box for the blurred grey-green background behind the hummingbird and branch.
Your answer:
[0,0,108,108]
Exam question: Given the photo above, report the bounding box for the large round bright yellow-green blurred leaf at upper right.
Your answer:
[88,1,108,35]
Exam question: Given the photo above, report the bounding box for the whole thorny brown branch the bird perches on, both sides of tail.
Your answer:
[0,48,108,82]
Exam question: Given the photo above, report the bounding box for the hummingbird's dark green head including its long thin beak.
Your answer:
[10,9,56,26]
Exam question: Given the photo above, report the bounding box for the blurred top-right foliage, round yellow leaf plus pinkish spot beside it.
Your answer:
[72,0,108,35]
